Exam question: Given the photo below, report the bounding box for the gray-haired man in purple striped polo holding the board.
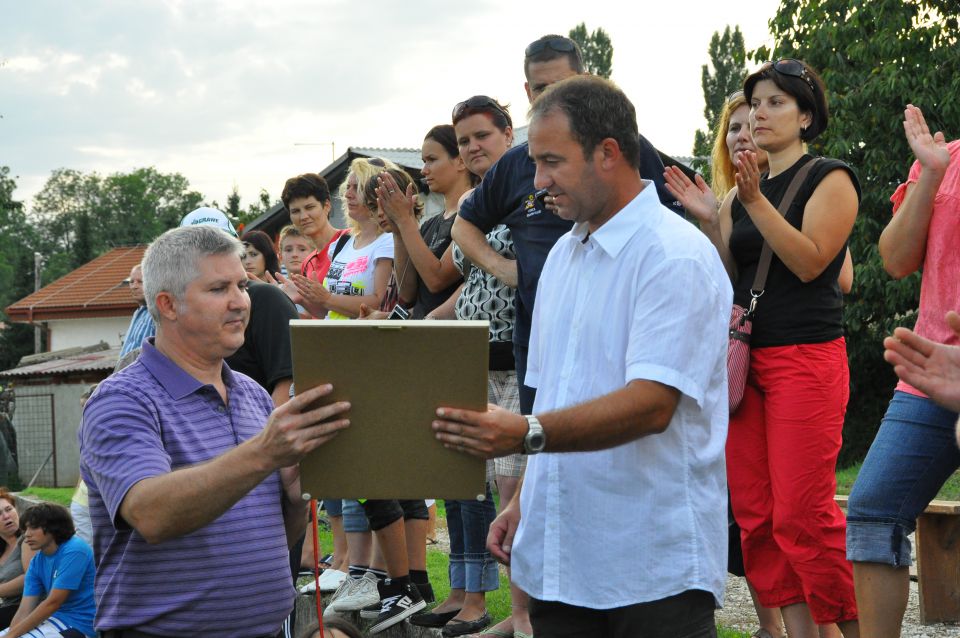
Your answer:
[80,226,349,638]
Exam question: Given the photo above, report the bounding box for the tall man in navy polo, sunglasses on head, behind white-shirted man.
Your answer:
[452,35,683,414]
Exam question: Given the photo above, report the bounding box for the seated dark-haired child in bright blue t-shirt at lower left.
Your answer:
[0,503,96,638]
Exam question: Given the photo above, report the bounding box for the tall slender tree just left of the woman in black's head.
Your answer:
[693,26,747,182]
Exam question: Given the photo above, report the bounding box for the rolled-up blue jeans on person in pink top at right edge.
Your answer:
[847,391,960,567]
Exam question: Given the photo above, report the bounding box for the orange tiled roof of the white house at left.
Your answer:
[6,246,146,322]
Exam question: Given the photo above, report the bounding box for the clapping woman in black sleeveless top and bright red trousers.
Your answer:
[668,59,860,638]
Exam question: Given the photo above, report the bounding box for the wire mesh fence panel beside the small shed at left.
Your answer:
[13,394,60,487]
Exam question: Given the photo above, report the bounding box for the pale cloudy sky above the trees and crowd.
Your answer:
[0,0,778,214]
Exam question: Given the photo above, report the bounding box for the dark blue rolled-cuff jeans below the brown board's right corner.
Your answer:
[444,486,500,594]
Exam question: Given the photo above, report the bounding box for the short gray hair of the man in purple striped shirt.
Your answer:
[142,225,244,324]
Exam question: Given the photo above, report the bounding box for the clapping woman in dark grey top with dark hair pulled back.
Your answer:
[371,124,473,319]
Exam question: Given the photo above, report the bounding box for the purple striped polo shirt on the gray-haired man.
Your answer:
[80,338,295,638]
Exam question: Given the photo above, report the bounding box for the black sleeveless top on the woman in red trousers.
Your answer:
[730,155,860,348]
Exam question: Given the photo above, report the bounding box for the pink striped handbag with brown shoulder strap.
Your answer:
[727,158,819,414]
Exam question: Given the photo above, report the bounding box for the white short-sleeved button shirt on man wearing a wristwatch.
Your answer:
[511,181,733,609]
